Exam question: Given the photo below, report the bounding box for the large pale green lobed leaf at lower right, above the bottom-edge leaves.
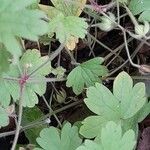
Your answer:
[80,72,149,138]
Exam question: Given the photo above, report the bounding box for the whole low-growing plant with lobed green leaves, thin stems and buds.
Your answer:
[0,0,150,150]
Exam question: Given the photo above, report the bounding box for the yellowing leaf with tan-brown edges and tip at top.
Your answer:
[39,0,88,50]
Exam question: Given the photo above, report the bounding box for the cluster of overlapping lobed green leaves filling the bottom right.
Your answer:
[35,72,150,150]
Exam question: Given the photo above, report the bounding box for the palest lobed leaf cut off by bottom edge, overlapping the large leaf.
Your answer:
[77,121,136,150]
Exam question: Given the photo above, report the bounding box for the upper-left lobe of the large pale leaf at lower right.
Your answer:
[84,83,120,120]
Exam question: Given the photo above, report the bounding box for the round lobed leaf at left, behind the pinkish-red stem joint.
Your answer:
[0,49,51,107]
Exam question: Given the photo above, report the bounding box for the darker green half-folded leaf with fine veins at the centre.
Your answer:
[66,57,107,94]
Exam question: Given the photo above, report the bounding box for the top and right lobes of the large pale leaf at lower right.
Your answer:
[113,72,147,119]
